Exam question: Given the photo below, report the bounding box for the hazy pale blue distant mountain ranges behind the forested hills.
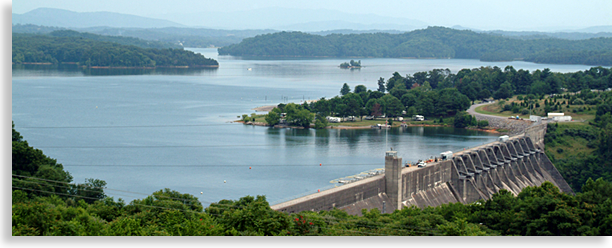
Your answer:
[12,8,612,47]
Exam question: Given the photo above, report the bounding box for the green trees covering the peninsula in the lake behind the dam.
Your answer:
[266,66,612,128]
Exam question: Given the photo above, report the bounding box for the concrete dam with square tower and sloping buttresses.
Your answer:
[271,123,574,215]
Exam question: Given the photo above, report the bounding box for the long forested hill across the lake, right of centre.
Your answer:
[219,27,612,66]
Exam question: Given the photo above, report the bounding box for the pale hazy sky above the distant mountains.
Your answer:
[12,0,612,30]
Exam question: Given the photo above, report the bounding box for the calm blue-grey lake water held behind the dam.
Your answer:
[12,49,590,206]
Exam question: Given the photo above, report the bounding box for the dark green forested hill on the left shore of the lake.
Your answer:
[12,33,219,67]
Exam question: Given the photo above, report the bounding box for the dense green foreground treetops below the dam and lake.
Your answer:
[11,119,612,236]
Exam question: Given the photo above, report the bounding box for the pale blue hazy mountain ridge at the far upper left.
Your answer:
[12,8,185,28]
